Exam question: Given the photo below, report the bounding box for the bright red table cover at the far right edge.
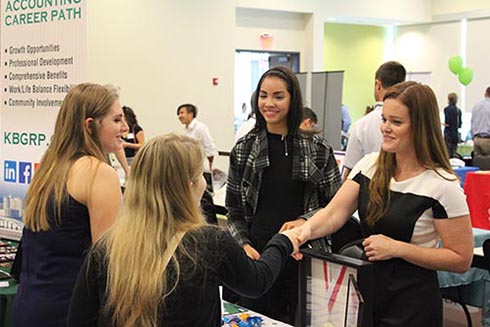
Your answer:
[464,171,490,230]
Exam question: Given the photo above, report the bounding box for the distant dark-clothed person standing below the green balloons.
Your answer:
[444,93,461,158]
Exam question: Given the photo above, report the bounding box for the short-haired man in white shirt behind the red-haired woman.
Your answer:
[343,61,406,180]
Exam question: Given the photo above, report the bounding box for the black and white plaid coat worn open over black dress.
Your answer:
[226,130,341,250]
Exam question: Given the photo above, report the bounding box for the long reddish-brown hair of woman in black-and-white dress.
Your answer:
[366,82,456,226]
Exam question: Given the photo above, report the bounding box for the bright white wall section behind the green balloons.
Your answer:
[396,18,490,112]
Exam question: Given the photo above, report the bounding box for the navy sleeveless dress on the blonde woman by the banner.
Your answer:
[13,196,91,327]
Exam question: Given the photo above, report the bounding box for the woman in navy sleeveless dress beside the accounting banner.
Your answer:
[13,83,128,327]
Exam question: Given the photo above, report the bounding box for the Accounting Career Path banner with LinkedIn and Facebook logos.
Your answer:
[0,0,87,223]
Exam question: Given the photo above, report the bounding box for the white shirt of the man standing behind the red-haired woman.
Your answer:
[344,102,383,169]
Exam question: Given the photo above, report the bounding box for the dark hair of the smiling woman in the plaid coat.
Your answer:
[252,66,304,135]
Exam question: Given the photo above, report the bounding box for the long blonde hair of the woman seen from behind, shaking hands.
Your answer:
[100,134,205,327]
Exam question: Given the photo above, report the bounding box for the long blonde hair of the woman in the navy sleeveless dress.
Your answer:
[24,83,118,232]
